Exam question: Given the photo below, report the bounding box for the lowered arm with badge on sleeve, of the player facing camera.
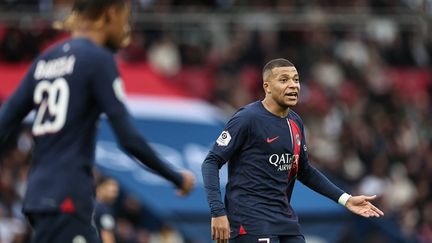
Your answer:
[201,113,249,242]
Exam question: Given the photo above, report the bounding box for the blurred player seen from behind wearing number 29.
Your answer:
[0,0,194,243]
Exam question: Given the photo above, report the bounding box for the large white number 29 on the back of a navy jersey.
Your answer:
[33,78,69,136]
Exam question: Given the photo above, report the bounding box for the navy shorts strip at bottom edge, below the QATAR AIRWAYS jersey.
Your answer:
[229,235,306,243]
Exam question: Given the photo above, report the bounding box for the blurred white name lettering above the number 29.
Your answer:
[34,55,75,80]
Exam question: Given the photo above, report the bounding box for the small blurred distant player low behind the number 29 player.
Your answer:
[94,177,119,243]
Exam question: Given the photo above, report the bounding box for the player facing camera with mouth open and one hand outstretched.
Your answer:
[202,59,384,243]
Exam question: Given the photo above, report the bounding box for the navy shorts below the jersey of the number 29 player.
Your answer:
[27,213,101,243]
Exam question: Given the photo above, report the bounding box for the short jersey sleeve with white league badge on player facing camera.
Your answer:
[212,112,250,161]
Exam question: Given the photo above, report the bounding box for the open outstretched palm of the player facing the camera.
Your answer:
[345,195,384,218]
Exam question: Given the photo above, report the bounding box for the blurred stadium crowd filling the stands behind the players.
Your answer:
[0,0,432,243]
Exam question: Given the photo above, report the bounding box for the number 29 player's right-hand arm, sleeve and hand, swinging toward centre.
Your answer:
[92,55,194,195]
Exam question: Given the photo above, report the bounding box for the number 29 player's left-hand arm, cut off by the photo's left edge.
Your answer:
[0,67,33,151]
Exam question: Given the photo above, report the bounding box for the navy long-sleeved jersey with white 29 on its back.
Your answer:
[0,38,181,220]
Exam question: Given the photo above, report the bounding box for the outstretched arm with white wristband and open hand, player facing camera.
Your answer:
[297,122,384,217]
